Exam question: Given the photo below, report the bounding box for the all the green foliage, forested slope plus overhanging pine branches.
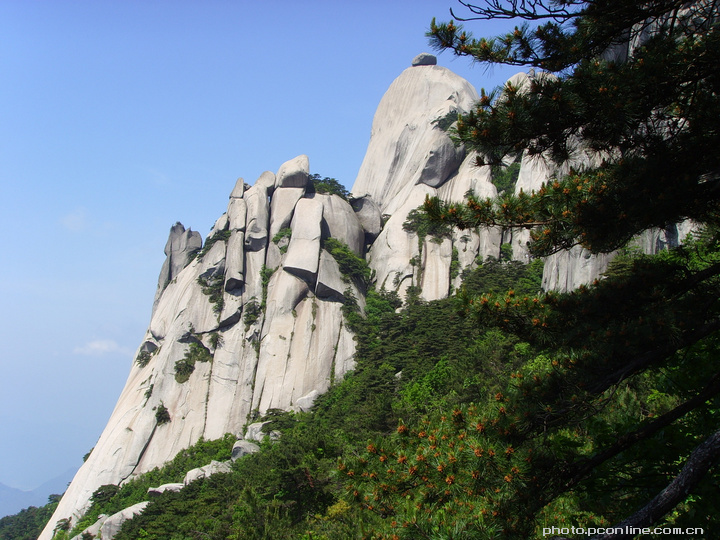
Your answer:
[39,0,720,540]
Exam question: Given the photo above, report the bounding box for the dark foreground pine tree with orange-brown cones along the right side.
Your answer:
[341,0,720,538]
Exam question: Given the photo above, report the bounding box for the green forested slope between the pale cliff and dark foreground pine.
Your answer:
[94,265,529,539]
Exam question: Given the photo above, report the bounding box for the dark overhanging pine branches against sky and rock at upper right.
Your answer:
[426,0,720,256]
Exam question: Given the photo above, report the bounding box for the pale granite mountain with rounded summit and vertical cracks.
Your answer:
[40,54,678,540]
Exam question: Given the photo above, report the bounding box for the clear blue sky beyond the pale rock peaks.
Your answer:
[0,0,515,489]
